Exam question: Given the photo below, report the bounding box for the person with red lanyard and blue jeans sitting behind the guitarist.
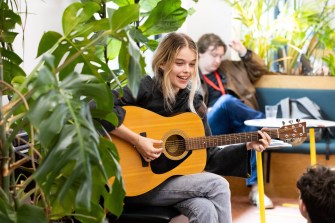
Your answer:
[197,33,274,208]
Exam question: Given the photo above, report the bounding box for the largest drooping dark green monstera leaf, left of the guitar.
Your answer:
[28,58,124,220]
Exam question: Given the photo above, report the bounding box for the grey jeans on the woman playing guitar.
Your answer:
[126,172,232,223]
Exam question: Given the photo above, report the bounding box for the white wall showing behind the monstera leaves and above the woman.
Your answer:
[14,0,240,74]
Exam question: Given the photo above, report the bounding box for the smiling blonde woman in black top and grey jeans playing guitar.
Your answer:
[101,33,271,223]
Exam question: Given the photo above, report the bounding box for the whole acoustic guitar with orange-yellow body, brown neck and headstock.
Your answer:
[110,106,306,196]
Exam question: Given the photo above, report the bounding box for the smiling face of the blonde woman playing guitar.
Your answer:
[163,47,197,93]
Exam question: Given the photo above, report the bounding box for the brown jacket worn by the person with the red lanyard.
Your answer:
[200,50,269,110]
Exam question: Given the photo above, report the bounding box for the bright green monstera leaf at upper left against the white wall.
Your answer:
[37,2,110,80]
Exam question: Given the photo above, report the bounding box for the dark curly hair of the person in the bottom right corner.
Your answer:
[297,165,335,223]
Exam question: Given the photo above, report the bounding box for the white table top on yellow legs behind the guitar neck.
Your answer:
[244,118,335,128]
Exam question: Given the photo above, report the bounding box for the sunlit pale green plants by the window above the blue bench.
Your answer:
[225,0,335,75]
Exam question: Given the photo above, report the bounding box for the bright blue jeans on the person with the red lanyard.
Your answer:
[207,94,265,186]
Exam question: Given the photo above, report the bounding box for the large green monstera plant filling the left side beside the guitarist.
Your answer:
[0,0,194,223]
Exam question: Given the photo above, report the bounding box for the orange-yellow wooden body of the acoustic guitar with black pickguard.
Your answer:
[112,106,206,196]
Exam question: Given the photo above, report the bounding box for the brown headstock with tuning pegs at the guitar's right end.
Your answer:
[278,122,307,142]
